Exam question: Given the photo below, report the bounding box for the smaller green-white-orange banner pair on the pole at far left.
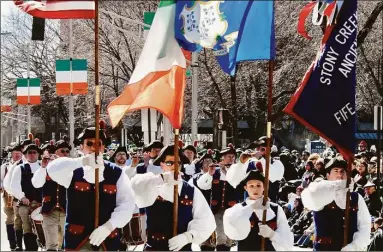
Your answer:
[17,78,40,105]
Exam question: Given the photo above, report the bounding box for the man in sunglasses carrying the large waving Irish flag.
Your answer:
[132,145,216,251]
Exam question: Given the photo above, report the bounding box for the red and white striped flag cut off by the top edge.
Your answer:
[14,0,95,19]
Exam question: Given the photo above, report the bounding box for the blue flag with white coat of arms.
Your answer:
[175,0,275,75]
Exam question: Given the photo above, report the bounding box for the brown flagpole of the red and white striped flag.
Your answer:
[94,0,100,250]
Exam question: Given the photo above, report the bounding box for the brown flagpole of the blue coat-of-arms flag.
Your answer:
[261,60,274,251]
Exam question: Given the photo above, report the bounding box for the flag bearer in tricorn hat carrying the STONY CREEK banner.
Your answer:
[302,158,371,251]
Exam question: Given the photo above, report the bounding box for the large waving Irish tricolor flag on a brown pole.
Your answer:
[108,1,186,128]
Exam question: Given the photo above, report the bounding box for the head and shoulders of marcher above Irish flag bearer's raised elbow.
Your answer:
[136,140,164,174]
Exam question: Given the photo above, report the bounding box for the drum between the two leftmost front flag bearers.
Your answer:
[122,207,146,246]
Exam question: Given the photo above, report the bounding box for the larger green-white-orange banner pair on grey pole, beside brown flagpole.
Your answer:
[56,59,88,95]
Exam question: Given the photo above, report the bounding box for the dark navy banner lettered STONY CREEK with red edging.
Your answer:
[284,0,357,158]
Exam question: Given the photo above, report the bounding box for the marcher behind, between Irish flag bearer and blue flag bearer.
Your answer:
[197,145,240,251]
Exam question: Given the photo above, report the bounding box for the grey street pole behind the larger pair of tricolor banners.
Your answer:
[69,19,75,157]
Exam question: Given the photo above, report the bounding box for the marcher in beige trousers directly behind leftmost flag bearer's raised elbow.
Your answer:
[32,140,70,251]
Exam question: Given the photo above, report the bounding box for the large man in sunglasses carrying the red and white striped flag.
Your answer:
[47,124,134,251]
